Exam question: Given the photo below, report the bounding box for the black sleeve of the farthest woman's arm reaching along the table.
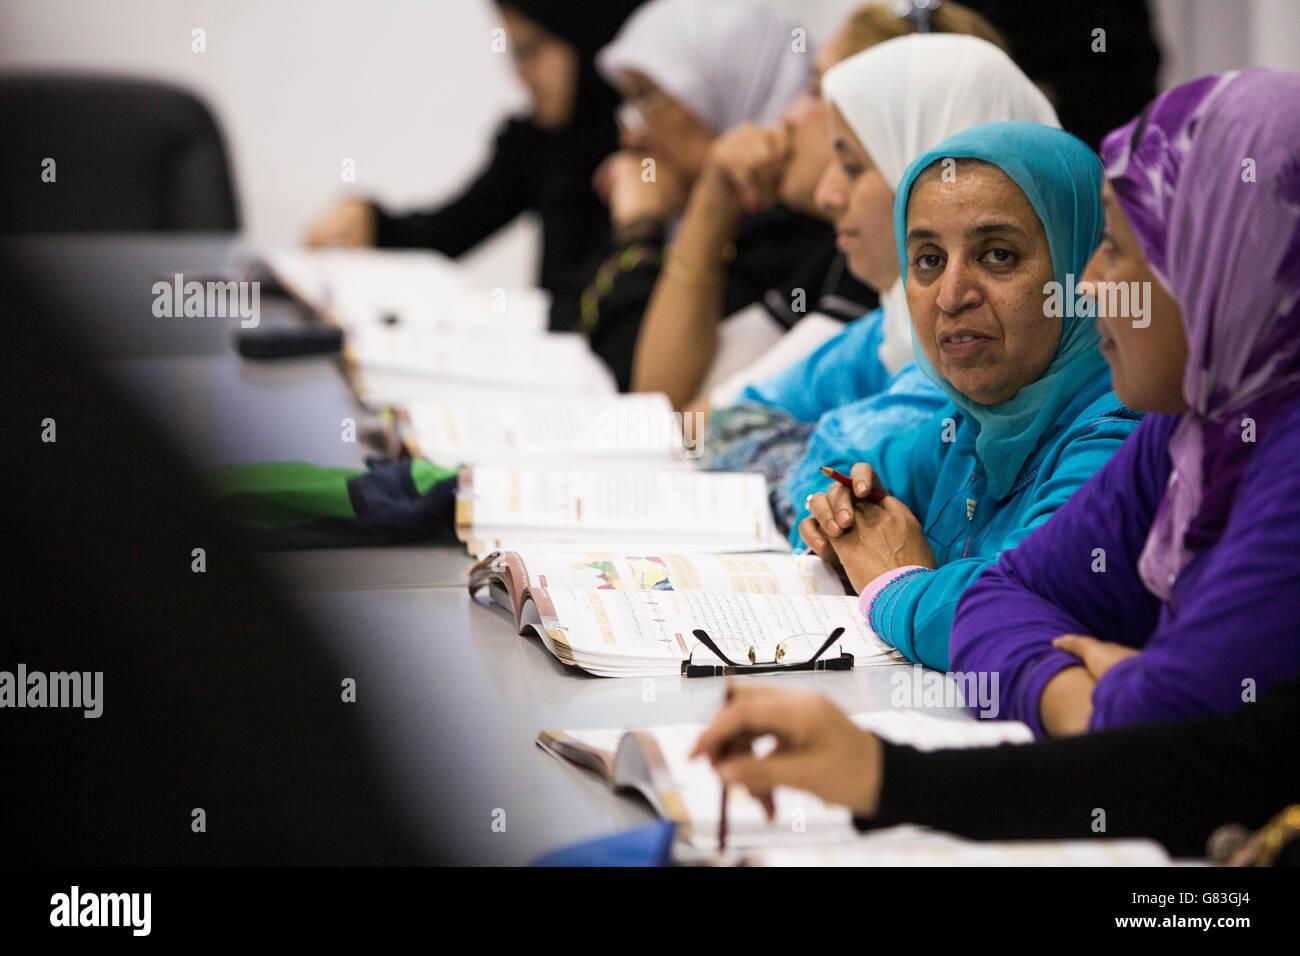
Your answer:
[372,120,543,256]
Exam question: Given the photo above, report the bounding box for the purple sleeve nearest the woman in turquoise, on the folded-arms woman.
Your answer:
[950,415,1177,736]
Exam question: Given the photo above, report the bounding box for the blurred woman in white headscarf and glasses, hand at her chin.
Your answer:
[551,0,870,389]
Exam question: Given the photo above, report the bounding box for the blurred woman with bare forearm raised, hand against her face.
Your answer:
[633,3,1014,411]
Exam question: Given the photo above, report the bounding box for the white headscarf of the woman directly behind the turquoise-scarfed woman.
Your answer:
[822,34,1061,375]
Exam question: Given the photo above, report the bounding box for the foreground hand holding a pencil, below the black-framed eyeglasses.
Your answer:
[690,682,884,819]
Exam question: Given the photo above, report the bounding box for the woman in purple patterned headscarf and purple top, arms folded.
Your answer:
[950,69,1300,736]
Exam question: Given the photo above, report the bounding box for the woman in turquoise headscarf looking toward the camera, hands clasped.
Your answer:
[800,122,1139,670]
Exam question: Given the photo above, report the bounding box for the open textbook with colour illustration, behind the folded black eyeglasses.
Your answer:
[469,550,905,678]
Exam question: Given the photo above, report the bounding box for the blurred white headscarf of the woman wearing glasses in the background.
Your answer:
[595,0,813,133]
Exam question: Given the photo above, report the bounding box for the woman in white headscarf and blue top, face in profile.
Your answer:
[706,34,1060,544]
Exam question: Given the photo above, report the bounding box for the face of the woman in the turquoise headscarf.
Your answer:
[906,160,1061,405]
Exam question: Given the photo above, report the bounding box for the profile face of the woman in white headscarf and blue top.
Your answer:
[816,104,898,291]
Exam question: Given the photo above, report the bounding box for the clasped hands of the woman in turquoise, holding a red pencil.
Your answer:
[800,462,939,593]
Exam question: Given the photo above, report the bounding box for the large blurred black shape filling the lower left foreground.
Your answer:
[0,261,421,865]
